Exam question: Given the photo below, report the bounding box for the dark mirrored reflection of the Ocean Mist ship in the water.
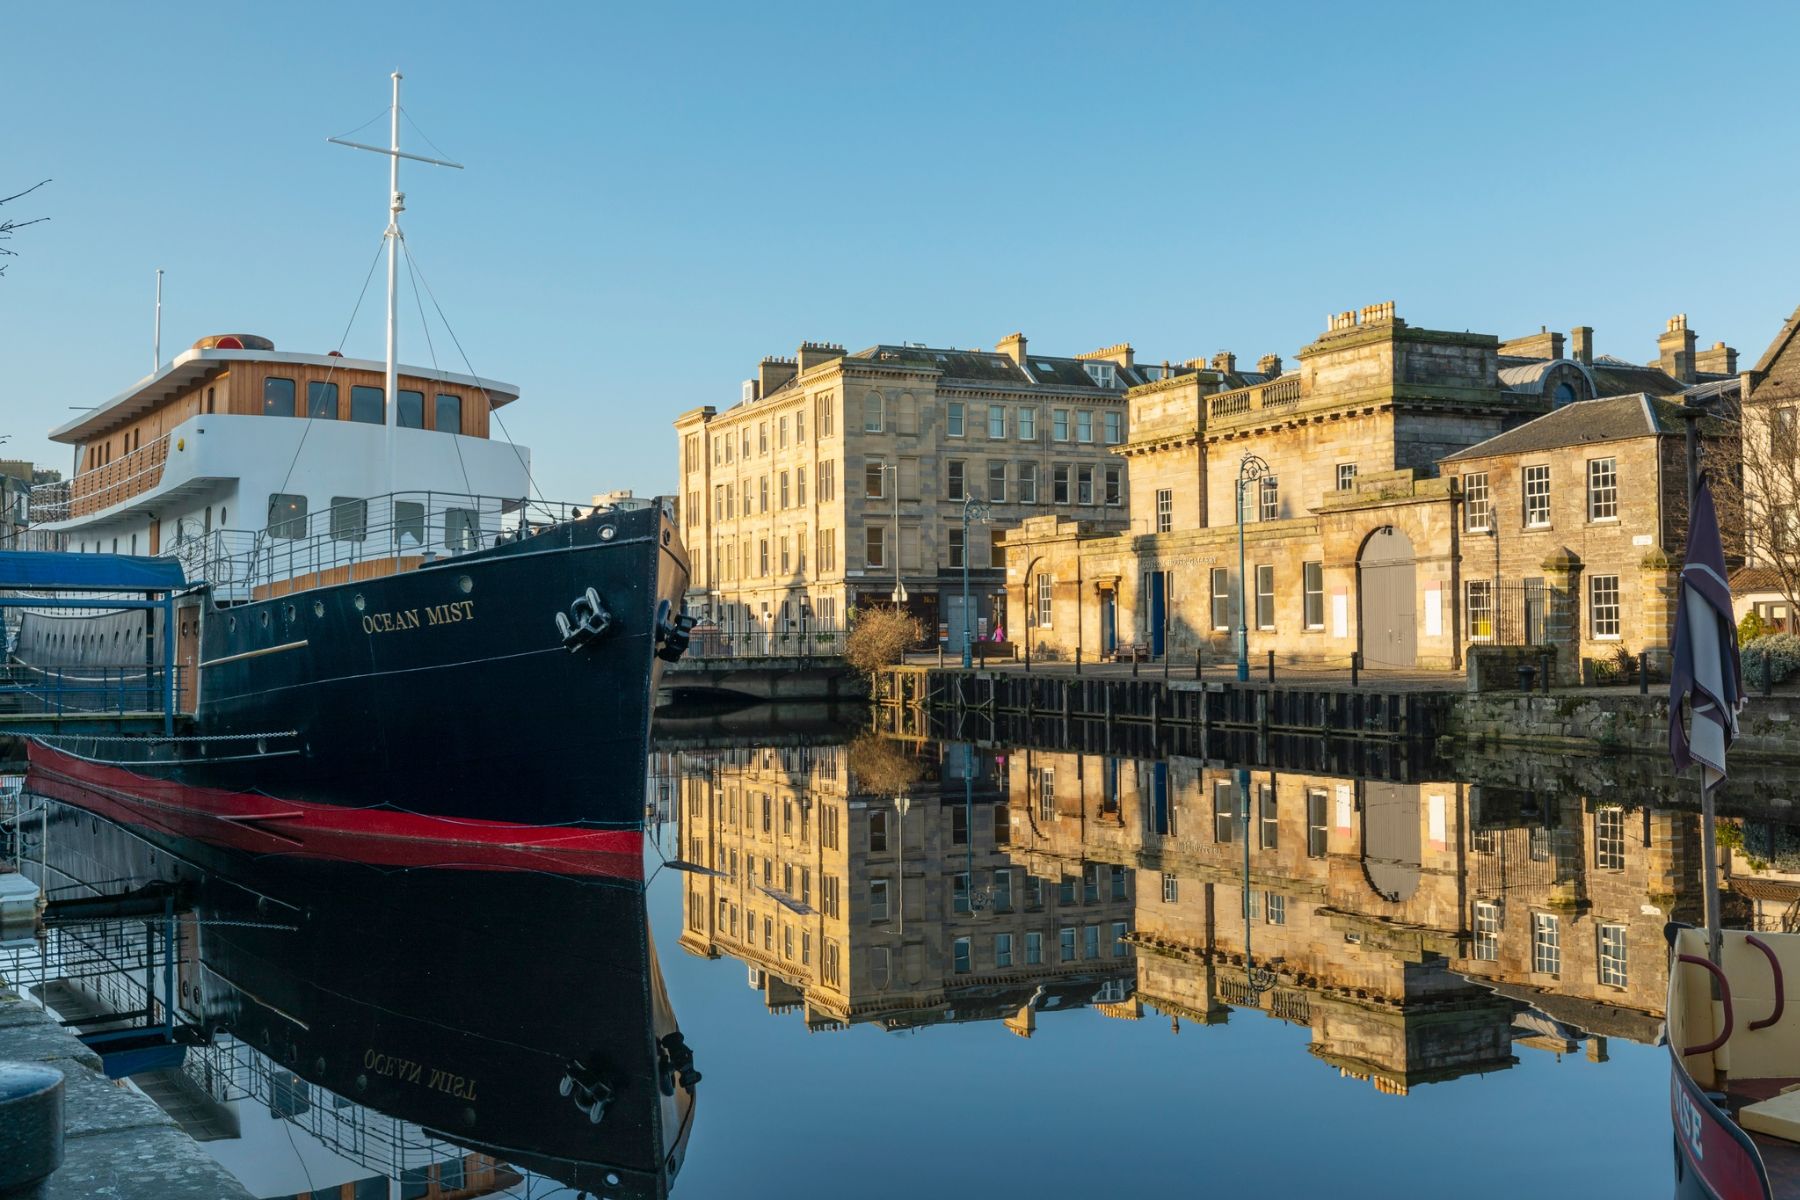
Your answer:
[7,806,698,1196]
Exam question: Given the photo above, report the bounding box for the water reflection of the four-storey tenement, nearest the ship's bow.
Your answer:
[668,738,1134,1036]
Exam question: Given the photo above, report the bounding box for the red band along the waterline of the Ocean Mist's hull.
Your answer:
[25,741,644,882]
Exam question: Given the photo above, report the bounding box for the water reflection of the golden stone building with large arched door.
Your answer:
[1006,750,1697,1092]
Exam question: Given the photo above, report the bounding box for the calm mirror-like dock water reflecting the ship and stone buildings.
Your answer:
[0,712,1800,1196]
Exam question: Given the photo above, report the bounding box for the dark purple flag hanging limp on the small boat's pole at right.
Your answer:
[1669,475,1744,788]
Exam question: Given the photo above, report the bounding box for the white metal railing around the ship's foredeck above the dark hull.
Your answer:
[171,491,630,603]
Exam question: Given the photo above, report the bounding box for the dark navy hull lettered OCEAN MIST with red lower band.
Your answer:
[22,507,688,853]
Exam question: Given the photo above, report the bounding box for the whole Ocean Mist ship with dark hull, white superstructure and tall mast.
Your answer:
[0,74,693,871]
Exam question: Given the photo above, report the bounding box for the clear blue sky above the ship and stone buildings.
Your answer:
[0,2,1800,498]
